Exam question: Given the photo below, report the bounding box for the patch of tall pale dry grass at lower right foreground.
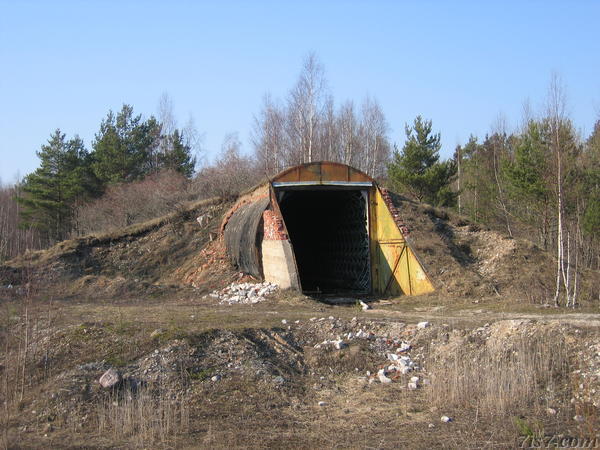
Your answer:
[428,338,569,416]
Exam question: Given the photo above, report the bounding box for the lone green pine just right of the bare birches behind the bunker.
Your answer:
[388,116,457,206]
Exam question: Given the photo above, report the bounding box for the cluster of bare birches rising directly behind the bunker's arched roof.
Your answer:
[252,53,391,177]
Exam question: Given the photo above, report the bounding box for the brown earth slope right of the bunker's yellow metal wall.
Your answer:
[391,193,600,305]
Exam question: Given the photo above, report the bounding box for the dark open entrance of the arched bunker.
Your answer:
[279,189,371,294]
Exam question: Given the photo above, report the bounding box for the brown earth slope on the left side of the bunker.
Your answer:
[0,199,235,298]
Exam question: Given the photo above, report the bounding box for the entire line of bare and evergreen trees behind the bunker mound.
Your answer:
[0,54,600,305]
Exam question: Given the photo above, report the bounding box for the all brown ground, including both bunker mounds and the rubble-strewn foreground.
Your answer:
[0,197,600,449]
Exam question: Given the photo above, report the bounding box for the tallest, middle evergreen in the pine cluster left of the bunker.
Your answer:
[92,105,160,183]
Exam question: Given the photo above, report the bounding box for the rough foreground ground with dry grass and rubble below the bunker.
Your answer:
[0,297,600,448]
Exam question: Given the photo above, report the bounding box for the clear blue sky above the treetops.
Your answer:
[0,0,600,183]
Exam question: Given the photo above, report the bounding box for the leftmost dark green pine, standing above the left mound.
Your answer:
[18,129,94,242]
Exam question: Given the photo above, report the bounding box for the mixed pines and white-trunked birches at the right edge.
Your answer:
[453,77,600,306]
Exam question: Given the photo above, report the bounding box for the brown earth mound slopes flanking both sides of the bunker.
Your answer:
[0,185,600,305]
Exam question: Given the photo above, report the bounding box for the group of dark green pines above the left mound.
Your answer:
[8,105,195,244]
